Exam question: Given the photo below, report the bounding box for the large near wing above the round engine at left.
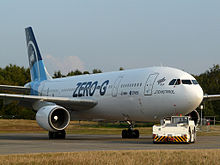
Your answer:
[0,93,97,110]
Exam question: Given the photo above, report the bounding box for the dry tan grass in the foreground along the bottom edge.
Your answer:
[0,150,220,165]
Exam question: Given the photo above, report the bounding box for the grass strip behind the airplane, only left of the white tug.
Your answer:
[0,119,152,135]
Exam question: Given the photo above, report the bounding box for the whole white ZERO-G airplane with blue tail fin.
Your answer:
[0,27,220,139]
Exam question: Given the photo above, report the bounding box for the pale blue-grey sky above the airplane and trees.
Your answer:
[0,0,220,74]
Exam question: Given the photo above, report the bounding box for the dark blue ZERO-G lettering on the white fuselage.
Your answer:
[73,80,109,97]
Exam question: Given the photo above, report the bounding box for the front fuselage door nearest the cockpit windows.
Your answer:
[144,73,159,96]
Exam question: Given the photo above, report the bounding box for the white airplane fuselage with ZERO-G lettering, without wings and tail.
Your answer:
[35,67,203,121]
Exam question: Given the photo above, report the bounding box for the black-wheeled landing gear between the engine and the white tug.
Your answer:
[121,121,139,139]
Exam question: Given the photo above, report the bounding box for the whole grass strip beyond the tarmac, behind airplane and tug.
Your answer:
[0,119,220,136]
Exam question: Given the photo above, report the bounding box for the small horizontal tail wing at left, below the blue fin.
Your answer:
[0,85,31,94]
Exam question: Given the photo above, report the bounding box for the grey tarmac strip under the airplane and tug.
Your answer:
[0,133,220,155]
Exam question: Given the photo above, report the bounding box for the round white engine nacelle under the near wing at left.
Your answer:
[36,105,70,132]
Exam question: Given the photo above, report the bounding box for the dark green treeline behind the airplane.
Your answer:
[0,64,220,120]
